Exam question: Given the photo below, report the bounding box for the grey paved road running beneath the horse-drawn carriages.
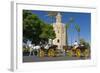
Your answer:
[23,56,85,62]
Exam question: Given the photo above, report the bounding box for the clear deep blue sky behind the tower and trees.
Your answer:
[32,10,91,44]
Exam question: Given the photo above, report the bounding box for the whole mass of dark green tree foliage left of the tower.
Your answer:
[23,10,55,45]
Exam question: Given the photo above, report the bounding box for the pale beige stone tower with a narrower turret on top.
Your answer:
[53,13,66,49]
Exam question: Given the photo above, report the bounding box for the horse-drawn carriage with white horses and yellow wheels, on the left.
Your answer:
[23,44,58,57]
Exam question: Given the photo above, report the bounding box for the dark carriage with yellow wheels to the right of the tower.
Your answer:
[66,45,90,58]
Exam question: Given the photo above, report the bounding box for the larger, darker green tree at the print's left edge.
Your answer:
[23,14,44,44]
